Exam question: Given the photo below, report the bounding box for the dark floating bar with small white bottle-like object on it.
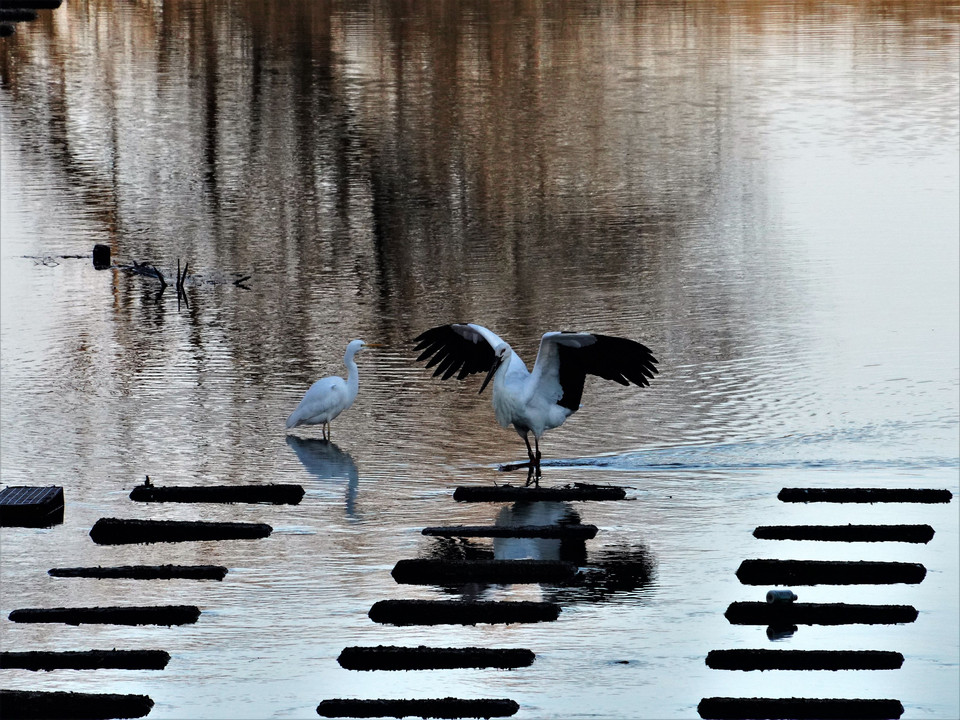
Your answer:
[724,602,918,627]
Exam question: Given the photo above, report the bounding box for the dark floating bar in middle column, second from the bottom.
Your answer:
[337,645,536,670]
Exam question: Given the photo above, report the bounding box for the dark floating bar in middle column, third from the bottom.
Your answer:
[367,600,560,625]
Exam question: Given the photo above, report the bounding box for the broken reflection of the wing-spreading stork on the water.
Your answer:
[425,502,656,605]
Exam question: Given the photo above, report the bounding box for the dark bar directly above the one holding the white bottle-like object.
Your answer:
[737,560,927,585]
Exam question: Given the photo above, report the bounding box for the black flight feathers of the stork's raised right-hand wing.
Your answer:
[557,335,657,411]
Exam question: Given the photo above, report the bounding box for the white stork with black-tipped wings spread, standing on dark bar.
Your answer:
[414,323,657,484]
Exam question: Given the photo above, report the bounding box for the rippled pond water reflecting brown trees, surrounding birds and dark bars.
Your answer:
[0,0,960,718]
